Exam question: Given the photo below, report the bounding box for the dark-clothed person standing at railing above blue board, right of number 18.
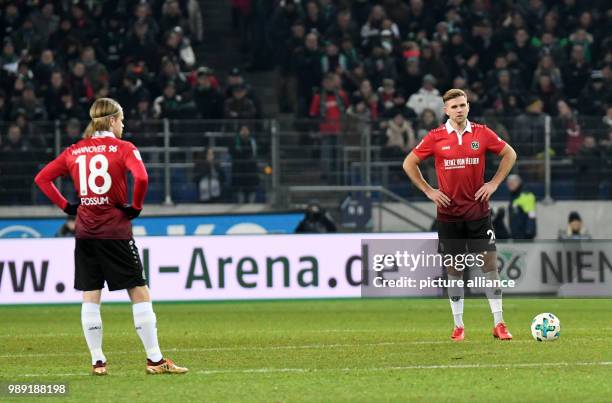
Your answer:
[230,125,259,204]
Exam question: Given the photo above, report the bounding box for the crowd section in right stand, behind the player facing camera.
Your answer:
[251,0,612,197]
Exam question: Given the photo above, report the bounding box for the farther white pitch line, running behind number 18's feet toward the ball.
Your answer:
[0,340,533,358]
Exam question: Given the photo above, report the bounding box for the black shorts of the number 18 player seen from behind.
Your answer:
[74,239,146,291]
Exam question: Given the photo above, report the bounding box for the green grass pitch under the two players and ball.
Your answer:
[0,298,612,402]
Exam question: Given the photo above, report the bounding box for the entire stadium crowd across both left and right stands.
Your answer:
[0,0,612,202]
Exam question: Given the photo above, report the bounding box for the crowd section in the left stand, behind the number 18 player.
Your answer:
[0,0,261,204]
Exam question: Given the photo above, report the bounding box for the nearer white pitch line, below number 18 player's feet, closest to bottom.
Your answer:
[15,361,612,378]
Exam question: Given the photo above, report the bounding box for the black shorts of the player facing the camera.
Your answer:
[437,215,497,255]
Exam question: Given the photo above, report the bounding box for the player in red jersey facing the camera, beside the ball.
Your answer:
[404,89,516,340]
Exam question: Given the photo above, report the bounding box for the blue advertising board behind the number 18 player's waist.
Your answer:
[0,212,304,238]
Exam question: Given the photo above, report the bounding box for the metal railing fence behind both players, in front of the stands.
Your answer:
[0,114,612,206]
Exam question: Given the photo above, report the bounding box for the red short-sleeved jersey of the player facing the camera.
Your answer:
[412,121,506,221]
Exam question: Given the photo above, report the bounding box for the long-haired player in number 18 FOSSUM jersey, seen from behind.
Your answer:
[35,98,187,375]
